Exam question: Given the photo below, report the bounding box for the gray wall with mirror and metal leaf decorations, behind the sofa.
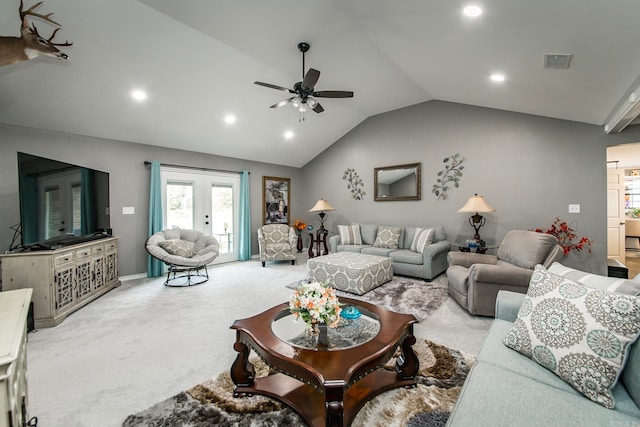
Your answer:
[302,101,640,273]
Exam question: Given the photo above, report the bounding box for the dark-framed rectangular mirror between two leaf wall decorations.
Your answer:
[373,163,421,202]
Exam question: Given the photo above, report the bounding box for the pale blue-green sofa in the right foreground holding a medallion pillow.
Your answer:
[447,267,640,427]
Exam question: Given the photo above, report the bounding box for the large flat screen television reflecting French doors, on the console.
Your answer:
[18,152,111,249]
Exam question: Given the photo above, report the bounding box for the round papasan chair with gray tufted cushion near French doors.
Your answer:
[145,228,220,286]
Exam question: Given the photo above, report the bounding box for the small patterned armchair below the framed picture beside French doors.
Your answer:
[258,224,298,267]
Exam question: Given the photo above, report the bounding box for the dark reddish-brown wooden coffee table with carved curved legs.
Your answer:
[231,298,419,427]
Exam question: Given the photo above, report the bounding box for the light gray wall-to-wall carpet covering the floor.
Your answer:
[22,255,491,427]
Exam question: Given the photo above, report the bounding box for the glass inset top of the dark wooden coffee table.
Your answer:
[271,306,380,351]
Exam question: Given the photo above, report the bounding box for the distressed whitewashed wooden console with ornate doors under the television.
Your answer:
[0,237,120,328]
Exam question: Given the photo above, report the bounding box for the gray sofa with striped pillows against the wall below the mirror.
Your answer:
[329,224,451,280]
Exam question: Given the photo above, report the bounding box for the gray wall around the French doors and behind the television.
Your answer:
[0,124,308,276]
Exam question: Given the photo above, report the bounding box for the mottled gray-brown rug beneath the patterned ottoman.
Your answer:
[287,274,449,321]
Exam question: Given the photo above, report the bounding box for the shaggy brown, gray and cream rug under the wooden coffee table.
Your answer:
[123,339,475,427]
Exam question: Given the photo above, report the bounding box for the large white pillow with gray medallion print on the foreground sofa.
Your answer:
[503,265,640,409]
